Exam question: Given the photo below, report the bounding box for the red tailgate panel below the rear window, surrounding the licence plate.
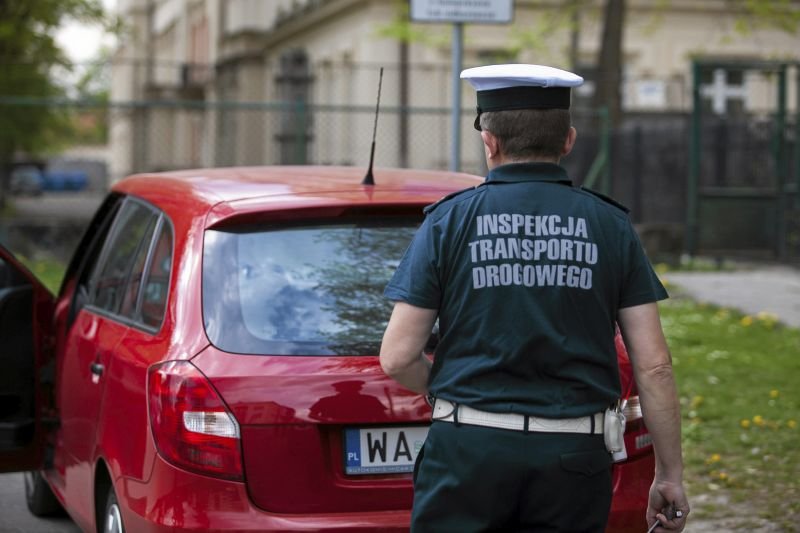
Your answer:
[192,348,430,513]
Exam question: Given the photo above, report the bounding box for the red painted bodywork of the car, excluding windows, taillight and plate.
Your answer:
[0,167,653,532]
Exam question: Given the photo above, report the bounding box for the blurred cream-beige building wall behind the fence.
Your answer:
[111,0,800,177]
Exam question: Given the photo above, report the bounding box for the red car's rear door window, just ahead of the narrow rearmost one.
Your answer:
[89,201,158,314]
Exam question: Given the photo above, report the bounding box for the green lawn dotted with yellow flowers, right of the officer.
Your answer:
[661,298,800,530]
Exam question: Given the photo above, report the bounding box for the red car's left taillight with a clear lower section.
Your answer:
[147,361,243,481]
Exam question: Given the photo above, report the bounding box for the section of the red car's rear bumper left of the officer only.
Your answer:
[115,457,410,533]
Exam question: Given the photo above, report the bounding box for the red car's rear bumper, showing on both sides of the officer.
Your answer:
[115,446,655,533]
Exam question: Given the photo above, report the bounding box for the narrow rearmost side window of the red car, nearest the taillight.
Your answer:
[140,222,172,328]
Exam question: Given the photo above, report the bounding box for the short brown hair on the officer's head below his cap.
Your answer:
[480,109,571,159]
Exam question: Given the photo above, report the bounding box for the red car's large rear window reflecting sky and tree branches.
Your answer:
[203,218,420,355]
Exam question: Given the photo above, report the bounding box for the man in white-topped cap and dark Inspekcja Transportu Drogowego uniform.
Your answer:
[380,65,689,532]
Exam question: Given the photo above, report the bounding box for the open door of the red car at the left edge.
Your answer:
[0,246,55,472]
